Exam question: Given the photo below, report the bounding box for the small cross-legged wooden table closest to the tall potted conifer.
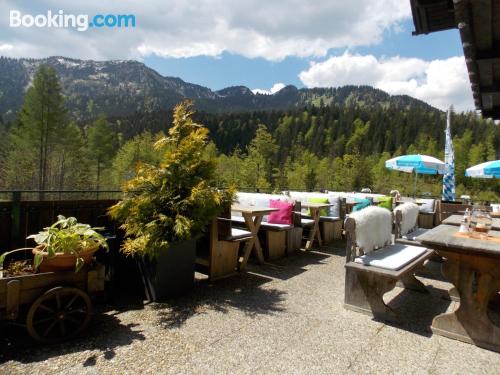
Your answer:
[231,205,278,271]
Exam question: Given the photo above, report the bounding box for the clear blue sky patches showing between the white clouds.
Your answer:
[144,19,463,90]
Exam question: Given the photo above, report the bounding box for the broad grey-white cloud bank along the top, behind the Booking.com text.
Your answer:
[0,0,411,60]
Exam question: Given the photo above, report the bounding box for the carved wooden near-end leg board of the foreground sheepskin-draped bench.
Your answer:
[344,268,397,321]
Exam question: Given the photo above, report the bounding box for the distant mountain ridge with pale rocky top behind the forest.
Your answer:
[0,57,432,121]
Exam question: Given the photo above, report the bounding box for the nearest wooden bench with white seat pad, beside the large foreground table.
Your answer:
[344,207,433,321]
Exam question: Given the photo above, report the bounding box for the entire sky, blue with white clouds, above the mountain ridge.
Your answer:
[0,0,473,110]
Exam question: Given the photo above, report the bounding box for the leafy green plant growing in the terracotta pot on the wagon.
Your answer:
[0,215,108,272]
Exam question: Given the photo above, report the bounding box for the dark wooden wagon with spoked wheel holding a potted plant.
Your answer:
[0,253,105,342]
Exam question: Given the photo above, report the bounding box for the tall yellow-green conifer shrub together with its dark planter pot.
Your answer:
[109,101,234,301]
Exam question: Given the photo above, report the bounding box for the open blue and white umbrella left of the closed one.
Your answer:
[385,155,445,195]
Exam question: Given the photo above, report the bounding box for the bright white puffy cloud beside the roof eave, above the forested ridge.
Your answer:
[299,52,474,111]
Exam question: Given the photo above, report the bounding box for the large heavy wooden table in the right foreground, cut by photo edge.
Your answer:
[417,225,500,352]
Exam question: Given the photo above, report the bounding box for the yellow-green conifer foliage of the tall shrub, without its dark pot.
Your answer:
[109,101,234,257]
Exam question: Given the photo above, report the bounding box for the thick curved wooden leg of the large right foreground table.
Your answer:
[431,251,500,352]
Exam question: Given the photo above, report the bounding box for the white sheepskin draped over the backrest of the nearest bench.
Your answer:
[349,206,392,254]
